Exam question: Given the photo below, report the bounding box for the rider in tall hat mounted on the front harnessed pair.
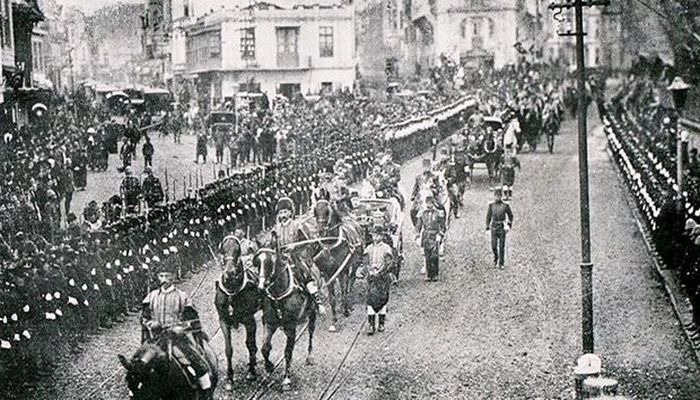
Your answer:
[272,197,325,314]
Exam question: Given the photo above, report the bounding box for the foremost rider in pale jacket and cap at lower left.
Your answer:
[141,263,212,390]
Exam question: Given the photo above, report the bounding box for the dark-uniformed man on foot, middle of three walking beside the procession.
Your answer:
[416,195,447,282]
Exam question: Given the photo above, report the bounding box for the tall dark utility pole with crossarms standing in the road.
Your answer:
[549,0,610,354]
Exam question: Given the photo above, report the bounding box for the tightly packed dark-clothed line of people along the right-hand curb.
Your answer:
[602,70,700,324]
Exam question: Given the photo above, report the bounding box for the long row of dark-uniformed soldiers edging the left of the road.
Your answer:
[0,85,470,388]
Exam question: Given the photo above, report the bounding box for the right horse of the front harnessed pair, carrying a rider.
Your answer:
[253,247,316,391]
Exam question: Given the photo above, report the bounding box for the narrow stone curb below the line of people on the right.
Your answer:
[605,147,700,364]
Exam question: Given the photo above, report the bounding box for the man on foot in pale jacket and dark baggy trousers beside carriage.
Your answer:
[358,225,394,335]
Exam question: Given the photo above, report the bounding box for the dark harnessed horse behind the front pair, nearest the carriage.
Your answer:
[307,200,365,332]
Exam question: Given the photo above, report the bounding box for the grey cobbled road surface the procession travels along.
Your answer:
[17,111,700,400]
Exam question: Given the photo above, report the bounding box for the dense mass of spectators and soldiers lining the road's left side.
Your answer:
[0,72,474,382]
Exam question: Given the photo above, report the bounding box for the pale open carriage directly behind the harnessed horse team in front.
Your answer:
[353,198,403,279]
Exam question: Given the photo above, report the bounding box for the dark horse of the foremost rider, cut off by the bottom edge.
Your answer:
[118,330,219,400]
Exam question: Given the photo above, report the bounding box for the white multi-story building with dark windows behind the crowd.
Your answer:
[180,0,355,106]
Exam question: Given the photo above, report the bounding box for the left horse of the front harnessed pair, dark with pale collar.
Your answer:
[214,236,262,390]
